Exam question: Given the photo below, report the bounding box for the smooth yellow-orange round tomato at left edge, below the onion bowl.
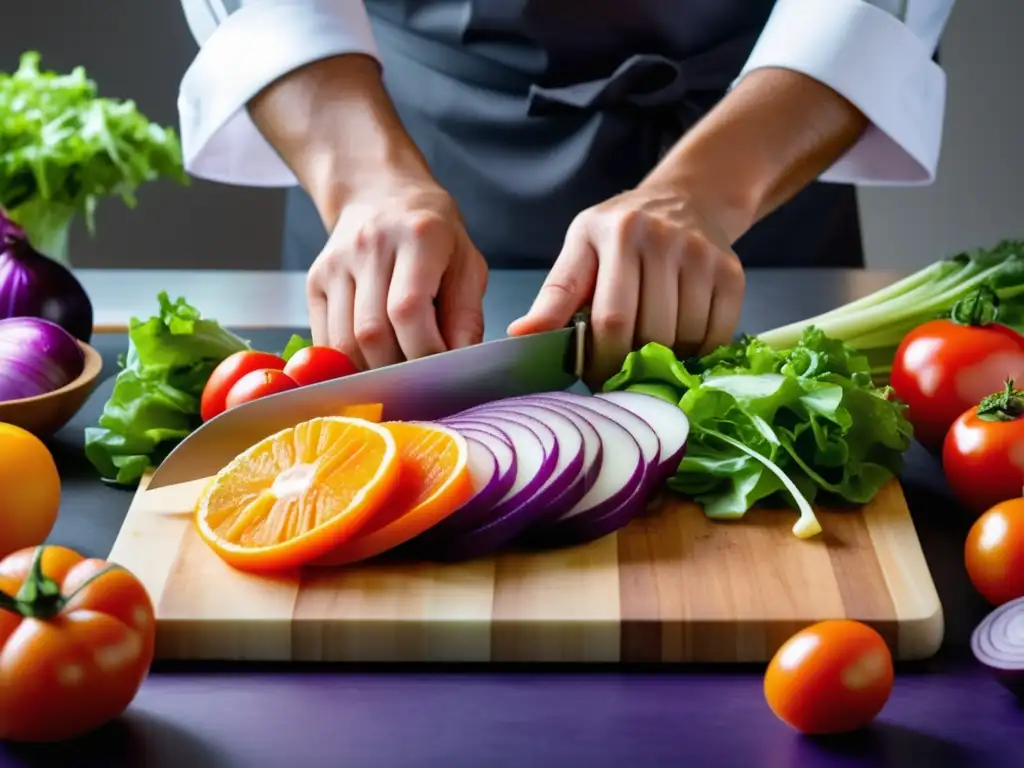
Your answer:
[0,424,60,557]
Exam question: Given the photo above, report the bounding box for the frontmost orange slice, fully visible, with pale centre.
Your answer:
[196,417,400,571]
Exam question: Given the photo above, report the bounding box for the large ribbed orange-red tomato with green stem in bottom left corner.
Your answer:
[0,547,157,741]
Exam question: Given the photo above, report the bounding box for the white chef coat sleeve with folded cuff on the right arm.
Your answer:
[736,0,954,185]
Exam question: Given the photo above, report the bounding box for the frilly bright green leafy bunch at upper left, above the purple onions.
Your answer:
[0,51,187,255]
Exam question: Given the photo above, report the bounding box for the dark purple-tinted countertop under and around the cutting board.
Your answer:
[6,271,1024,768]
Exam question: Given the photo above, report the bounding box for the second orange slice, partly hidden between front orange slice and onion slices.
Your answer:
[312,421,473,565]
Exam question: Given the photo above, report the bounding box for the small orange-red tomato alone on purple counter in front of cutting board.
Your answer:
[764,620,893,734]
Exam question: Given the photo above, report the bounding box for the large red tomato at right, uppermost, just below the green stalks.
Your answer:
[890,319,1024,450]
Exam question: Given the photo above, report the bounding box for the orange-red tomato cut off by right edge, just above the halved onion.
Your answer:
[964,497,1024,605]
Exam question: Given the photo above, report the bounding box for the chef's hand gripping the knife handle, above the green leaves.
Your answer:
[508,184,744,386]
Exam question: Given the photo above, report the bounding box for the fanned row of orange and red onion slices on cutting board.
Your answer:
[197,392,689,570]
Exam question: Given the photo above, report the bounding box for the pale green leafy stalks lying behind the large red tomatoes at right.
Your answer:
[758,240,1024,380]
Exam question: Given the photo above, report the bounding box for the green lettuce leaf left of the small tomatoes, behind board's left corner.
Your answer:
[85,292,249,485]
